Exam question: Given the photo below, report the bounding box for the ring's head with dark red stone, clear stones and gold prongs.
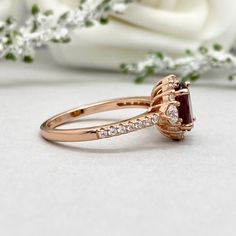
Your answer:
[150,75,194,140]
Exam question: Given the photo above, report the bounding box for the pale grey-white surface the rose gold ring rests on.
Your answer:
[0,52,236,236]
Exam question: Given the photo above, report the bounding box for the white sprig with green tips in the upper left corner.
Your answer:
[0,0,135,63]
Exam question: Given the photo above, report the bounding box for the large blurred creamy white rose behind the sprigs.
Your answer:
[25,0,236,69]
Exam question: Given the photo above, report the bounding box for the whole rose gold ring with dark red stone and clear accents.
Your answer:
[41,75,195,142]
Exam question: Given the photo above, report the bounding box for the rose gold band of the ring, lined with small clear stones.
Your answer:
[41,97,155,142]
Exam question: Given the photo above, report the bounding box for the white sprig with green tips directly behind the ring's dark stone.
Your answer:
[120,44,236,83]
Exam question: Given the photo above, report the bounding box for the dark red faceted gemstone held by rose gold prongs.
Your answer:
[176,82,193,125]
